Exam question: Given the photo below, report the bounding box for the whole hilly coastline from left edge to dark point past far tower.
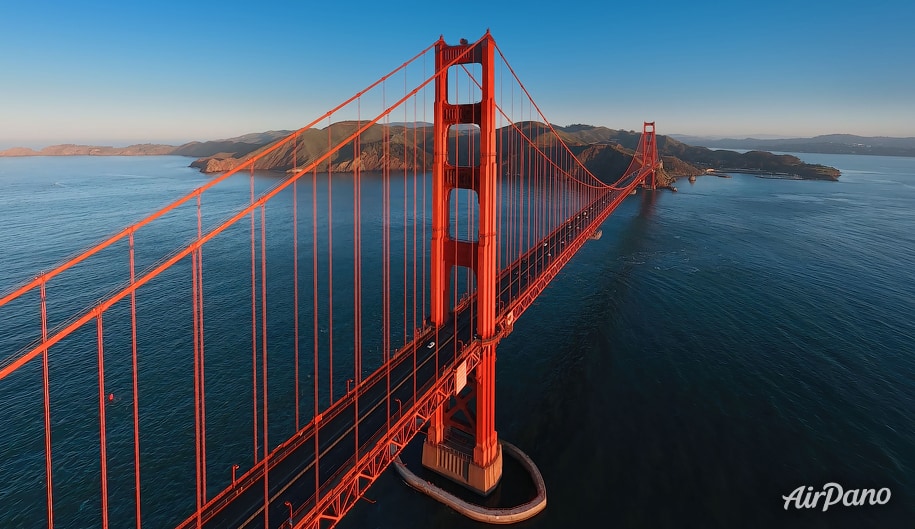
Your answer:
[0,121,839,180]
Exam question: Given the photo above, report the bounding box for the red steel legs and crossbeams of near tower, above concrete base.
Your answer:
[428,32,501,474]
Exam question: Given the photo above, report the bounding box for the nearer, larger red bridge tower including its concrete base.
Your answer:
[422,31,502,495]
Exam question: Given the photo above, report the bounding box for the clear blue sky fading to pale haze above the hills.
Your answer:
[0,0,915,148]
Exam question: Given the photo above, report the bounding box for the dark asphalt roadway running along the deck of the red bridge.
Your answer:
[179,187,629,529]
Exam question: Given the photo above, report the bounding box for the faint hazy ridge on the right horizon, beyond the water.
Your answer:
[674,134,915,157]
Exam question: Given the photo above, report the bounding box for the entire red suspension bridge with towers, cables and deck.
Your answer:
[0,32,661,528]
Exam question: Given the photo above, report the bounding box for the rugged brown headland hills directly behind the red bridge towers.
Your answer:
[191,121,839,182]
